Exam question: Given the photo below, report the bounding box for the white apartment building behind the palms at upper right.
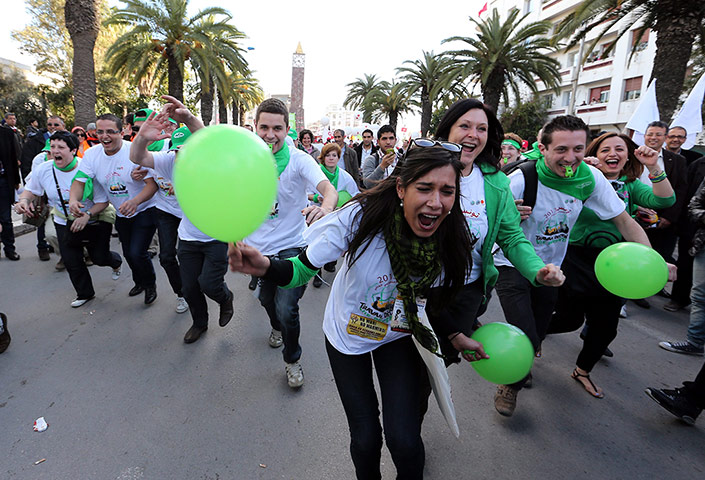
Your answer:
[483,0,656,132]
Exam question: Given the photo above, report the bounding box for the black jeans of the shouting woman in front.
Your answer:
[326,336,429,480]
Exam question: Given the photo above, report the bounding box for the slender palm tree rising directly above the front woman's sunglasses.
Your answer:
[397,51,466,136]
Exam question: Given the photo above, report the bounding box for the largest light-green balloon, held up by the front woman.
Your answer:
[174,125,277,242]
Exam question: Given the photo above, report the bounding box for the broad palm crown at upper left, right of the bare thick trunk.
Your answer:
[106,0,247,99]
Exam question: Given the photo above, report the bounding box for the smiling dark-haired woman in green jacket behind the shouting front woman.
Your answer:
[429,99,565,362]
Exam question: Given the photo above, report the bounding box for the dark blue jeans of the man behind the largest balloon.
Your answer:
[259,248,306,363]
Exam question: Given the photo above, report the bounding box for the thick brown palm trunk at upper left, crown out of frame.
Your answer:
[64,0,100,125]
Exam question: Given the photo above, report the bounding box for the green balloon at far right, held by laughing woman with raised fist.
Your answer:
[595,242,668,299]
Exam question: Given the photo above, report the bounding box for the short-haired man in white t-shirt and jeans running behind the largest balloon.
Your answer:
[236,98,338,388]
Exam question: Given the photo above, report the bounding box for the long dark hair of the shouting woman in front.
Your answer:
[346,146,474,296]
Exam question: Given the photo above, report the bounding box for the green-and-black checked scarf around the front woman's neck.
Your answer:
[384,208,442,357]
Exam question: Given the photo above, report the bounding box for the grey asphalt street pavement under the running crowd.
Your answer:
[0,233,705,480]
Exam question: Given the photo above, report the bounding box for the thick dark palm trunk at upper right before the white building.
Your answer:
[642,0,703,123]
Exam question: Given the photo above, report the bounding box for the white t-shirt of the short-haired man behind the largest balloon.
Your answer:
[245,148,328,261]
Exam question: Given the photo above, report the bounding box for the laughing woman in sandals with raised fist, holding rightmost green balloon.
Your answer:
[544,133,676,398]
